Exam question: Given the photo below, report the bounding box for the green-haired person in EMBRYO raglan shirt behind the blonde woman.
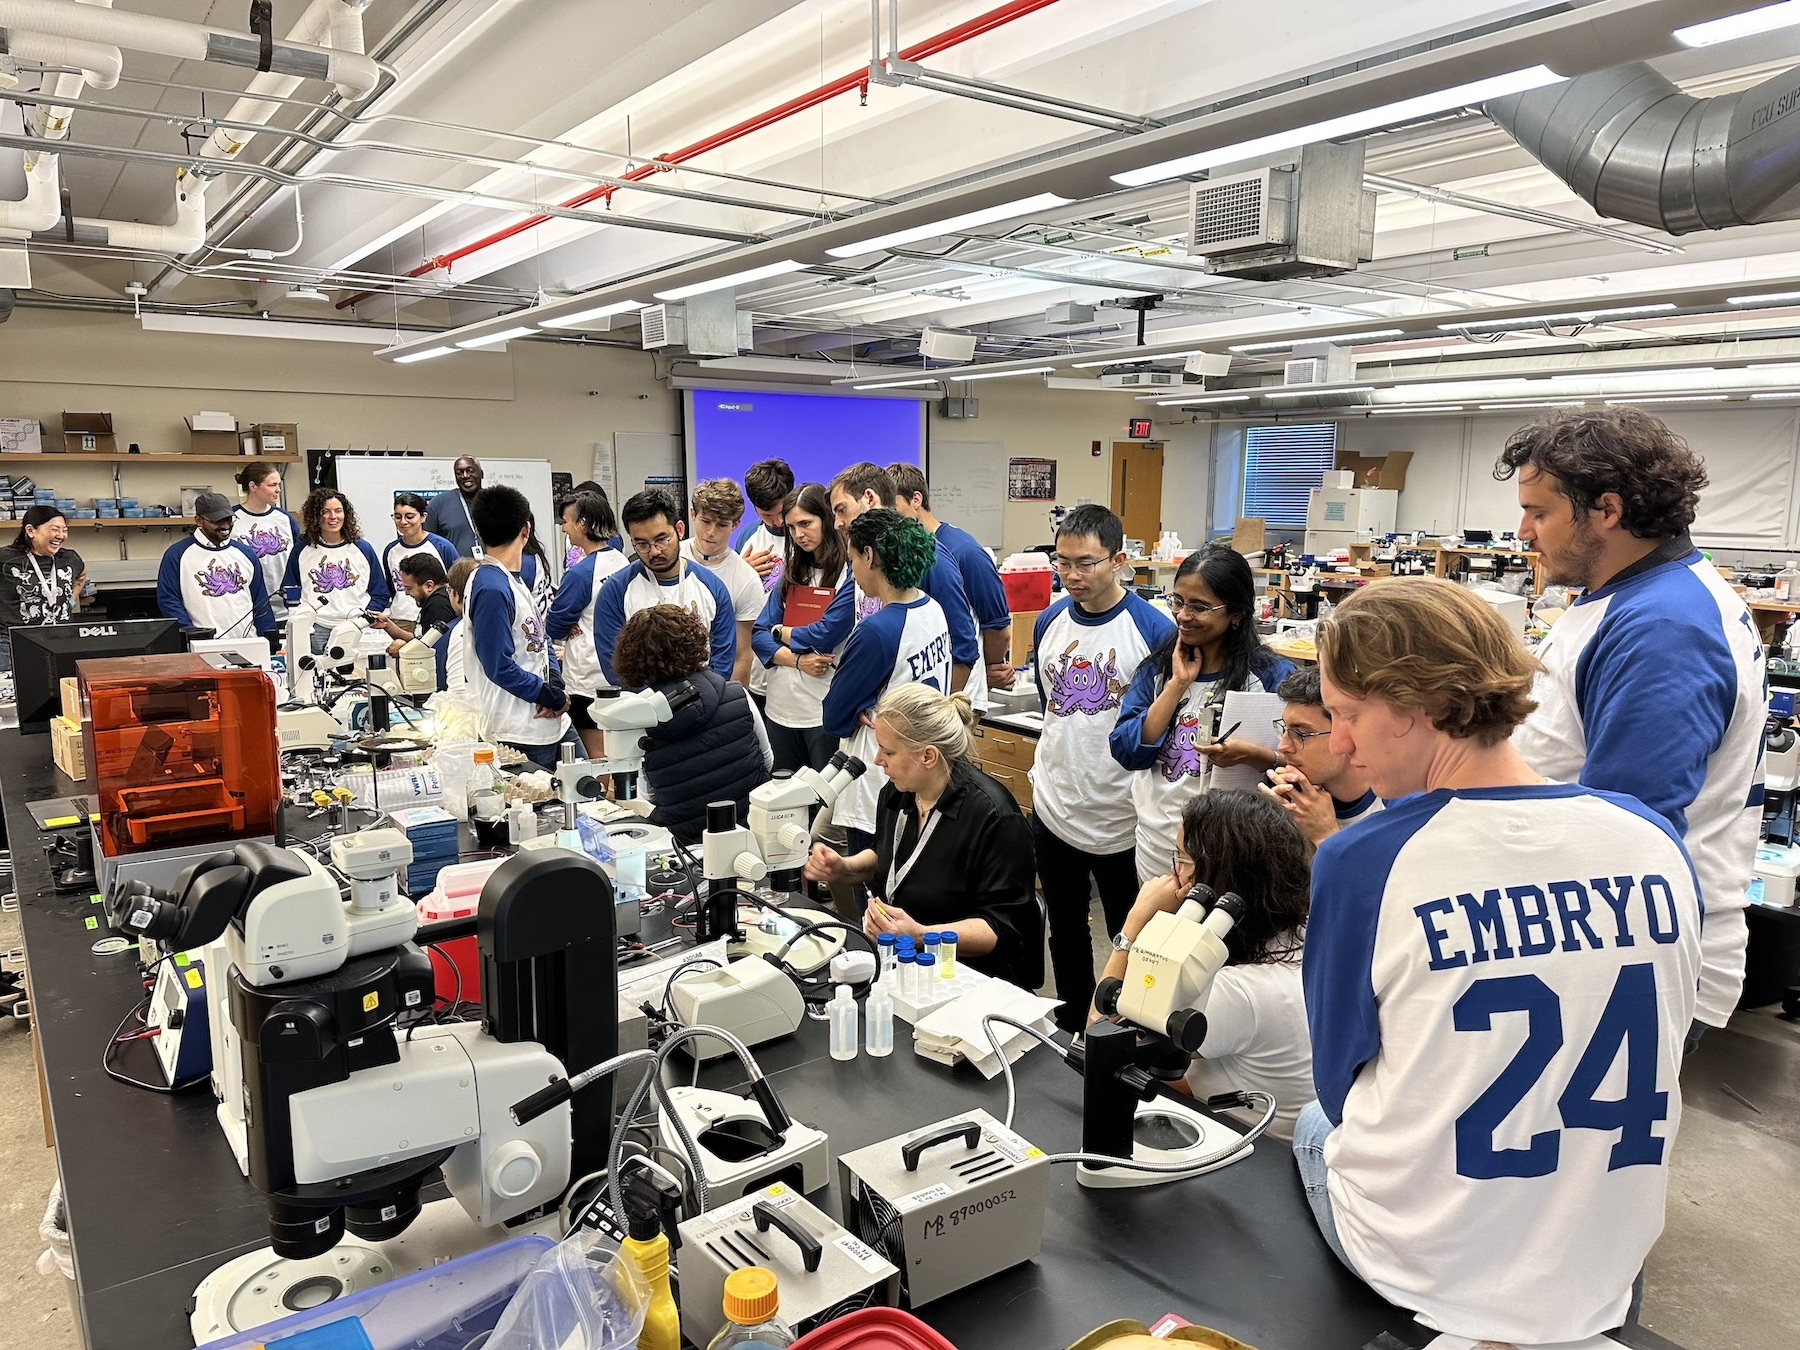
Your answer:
[821,508,952,857]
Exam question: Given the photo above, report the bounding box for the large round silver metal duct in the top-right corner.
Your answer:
[1483,61,1800,234]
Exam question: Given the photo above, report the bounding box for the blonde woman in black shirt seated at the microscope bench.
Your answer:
[806,684,1044,988]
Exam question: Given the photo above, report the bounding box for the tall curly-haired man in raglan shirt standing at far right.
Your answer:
[1494,407,1769,1049]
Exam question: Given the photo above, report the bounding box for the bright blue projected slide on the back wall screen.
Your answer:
[686,389,925,484]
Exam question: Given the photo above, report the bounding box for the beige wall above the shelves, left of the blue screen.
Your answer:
[0,310,680,558]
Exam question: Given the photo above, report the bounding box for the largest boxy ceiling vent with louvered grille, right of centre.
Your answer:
[1188,140,1375,281]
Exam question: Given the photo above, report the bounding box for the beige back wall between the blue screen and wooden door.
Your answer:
[931,376,1143,556]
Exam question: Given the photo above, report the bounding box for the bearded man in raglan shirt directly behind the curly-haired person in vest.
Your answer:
[594,488,738,684]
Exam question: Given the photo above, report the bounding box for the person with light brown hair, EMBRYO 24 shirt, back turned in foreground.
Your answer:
[1294,578,1701,1346]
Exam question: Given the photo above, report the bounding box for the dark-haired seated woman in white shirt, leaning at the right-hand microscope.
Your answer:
[1087,792,1314,1139]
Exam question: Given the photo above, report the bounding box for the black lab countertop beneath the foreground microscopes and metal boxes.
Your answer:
[0,731,1665,1350]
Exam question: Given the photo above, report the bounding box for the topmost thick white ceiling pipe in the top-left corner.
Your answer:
[0,0,382,99]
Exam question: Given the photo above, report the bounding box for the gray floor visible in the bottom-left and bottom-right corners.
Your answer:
[0,900,1800,1350]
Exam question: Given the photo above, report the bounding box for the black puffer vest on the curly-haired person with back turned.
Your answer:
[643,670,769,844]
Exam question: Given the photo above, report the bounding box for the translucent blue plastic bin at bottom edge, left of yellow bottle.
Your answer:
[205,1237,556,1350]
